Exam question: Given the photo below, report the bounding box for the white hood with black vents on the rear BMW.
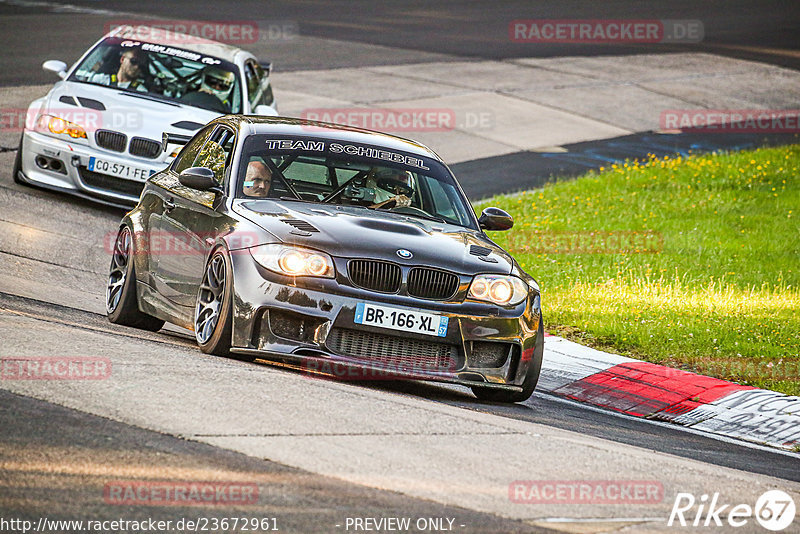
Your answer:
[46,81,220,142]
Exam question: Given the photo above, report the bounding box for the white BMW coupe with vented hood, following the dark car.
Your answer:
[14,26,277,207]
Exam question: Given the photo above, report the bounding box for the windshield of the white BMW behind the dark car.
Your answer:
[69,38,242,113]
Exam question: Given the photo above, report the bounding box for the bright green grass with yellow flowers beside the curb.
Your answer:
[476,145,800,395]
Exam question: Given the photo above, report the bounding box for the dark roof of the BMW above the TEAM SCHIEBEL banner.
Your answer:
[219,115,441,161]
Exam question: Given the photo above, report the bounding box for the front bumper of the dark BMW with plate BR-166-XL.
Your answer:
[231,250,541,390]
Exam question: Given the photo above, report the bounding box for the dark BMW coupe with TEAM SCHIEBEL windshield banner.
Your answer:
[106,116,544,402]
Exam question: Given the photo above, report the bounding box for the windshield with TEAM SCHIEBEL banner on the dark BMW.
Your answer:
[237,135,475,228]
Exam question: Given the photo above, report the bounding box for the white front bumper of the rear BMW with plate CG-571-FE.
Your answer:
[20,130,166,208]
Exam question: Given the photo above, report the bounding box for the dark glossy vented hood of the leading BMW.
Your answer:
[233,200,513,274]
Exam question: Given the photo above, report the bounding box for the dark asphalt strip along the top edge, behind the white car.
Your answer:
[0,0,800,85]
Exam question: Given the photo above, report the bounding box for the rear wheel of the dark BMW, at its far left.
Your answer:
[106,226,164,332]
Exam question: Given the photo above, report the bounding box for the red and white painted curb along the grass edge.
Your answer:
[537,335,800,450]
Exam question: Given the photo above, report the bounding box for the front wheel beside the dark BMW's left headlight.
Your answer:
[194,248,239,358]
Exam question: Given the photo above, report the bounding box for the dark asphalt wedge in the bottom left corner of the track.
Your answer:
[0,390,547,533]
